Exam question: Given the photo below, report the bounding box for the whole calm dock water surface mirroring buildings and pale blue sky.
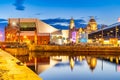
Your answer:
[16,52,120,80]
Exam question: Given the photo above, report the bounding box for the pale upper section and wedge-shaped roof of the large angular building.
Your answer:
[8,18,59,34]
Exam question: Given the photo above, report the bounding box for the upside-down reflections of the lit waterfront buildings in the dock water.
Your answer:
[16,53,120,74]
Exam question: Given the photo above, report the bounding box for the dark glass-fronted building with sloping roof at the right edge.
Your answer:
[88,22,120,45]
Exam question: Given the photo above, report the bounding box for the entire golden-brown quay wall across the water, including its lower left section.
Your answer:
[5,45,120,56]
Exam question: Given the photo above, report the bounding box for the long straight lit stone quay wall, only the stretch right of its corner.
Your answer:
[29,45,120,52]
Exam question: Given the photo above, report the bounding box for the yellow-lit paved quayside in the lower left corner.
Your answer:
[0,49,42,80]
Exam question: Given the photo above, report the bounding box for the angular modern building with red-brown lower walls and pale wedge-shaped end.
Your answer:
[5,18,59,45]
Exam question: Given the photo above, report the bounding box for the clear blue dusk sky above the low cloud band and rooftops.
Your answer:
[0,0,120,25]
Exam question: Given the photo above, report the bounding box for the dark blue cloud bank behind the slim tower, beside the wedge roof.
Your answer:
[42,18,86,29]
